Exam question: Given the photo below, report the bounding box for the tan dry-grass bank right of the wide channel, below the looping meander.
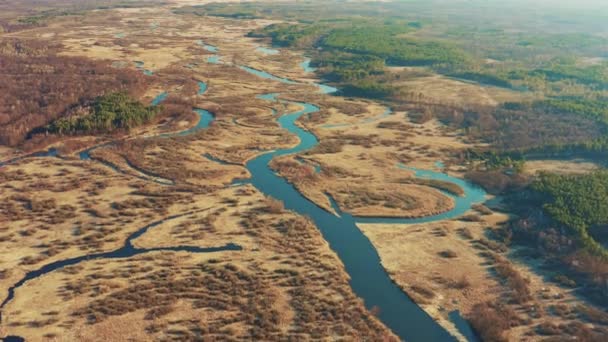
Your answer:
[357,214,506,341]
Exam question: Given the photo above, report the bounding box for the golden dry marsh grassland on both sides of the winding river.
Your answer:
[0,0,595,341]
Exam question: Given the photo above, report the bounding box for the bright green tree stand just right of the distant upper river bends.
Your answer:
[249,19,466,98]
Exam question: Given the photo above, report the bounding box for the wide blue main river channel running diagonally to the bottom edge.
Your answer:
[246,94,484,342]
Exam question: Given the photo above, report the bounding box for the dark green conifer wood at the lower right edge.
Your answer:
[474,170,608,305]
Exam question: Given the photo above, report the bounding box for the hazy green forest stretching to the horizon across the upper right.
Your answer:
[192,1,608,101]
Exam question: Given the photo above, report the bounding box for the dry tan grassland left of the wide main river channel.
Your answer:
[0,8,400,341]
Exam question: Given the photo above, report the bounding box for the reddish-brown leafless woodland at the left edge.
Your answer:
[0,39,150,146]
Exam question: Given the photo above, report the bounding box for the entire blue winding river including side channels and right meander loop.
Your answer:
[0,60,485,342]
